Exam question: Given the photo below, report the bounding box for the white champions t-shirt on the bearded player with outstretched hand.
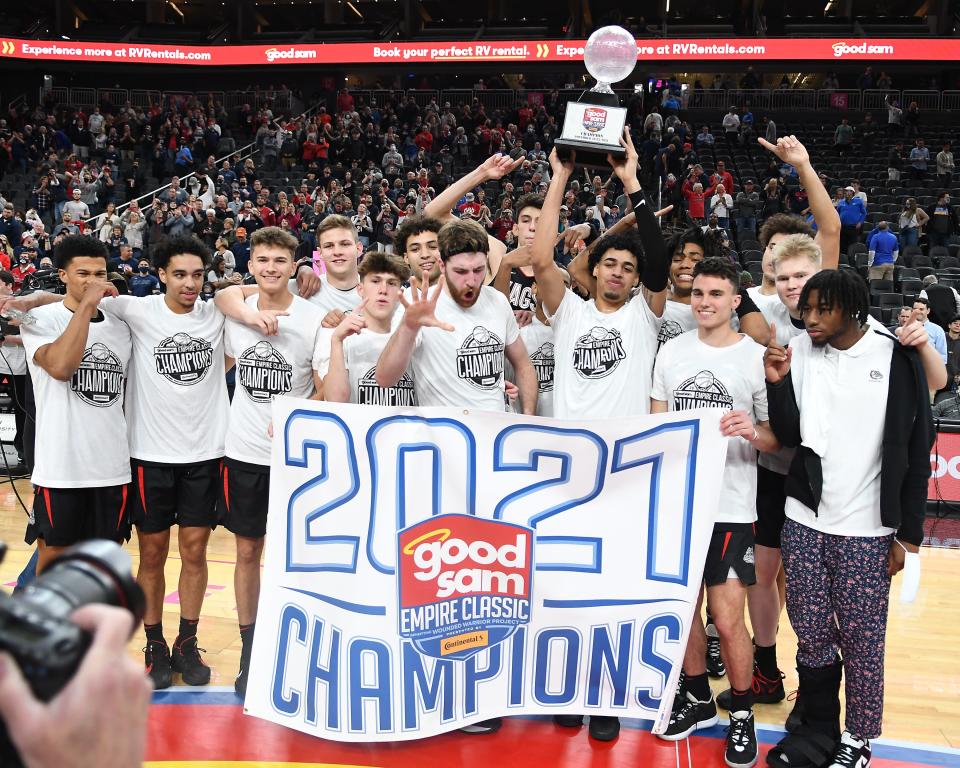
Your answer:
[410,286,520,411]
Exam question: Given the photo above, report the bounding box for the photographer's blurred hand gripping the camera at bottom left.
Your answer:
[0,605,153,768]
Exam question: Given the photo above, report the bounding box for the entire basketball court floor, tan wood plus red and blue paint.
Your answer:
[0,481,960,768]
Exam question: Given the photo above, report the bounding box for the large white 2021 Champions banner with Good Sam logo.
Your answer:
[246,398,726,741]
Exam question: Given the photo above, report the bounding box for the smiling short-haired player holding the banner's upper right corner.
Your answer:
[650,258,779,766]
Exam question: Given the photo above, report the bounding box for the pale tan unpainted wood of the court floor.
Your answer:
[0,481,960,766]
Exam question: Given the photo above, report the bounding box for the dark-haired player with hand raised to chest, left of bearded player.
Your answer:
[313,251,417,406]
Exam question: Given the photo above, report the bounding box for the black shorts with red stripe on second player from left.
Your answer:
[130,459,220,533]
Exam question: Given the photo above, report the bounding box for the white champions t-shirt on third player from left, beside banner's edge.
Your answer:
[224,294,323,466]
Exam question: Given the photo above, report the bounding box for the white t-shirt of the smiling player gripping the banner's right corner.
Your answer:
[651,331,767,523]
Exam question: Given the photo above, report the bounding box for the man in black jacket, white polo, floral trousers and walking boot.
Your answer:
[764,268,933,768]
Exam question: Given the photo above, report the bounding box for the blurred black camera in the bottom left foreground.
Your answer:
[0,539,145,768]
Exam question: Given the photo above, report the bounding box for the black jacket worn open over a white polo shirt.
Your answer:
[767,331,934,546]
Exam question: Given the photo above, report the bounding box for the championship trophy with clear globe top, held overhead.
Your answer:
[554,26,637,166]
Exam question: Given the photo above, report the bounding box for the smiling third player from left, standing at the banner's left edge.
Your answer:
[215,227,322,697]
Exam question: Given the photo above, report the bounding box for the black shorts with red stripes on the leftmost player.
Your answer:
[24,484,130,547]
